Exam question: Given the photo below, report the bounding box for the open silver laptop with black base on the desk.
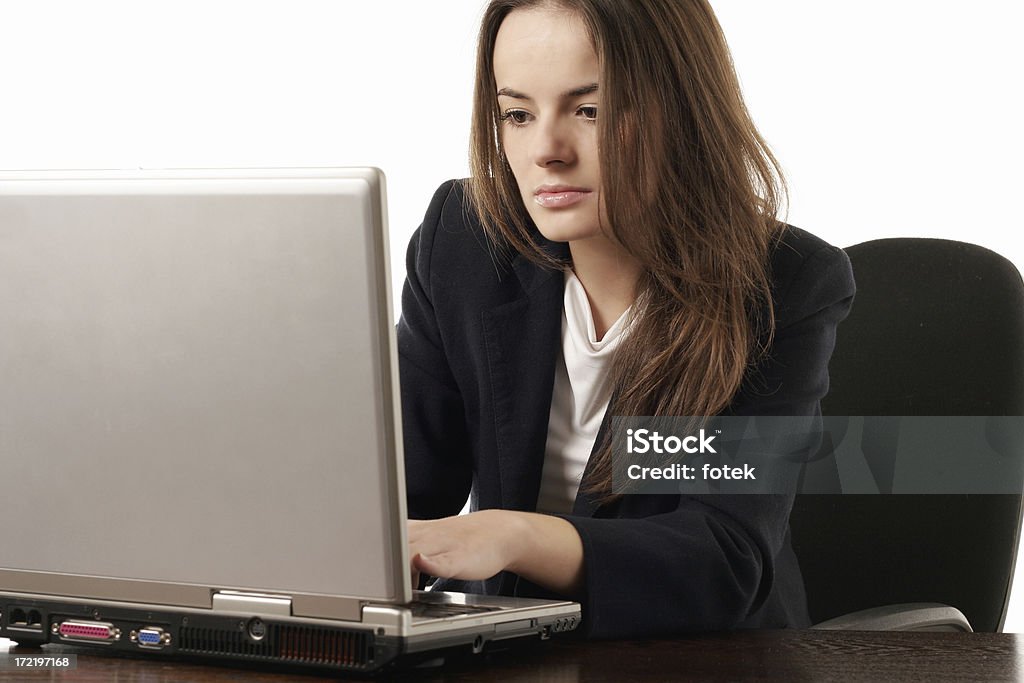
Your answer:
[0,168,581,672]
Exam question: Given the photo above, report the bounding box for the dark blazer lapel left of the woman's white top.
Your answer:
[482,256,564,512]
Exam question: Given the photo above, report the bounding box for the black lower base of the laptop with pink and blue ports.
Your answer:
[0,593,567,674]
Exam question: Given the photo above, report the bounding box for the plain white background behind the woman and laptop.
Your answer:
[6,0,1024,631]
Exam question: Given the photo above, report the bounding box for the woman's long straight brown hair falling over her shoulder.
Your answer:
[469,0,785,500]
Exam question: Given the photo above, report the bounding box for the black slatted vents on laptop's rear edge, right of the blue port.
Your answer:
[178,624,373,668]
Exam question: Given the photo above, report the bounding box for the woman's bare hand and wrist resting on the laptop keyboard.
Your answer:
[409,510,583,595]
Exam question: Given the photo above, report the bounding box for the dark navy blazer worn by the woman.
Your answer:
[397,181,854,638]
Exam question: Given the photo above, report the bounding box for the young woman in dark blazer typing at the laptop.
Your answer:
[398,0,854,637]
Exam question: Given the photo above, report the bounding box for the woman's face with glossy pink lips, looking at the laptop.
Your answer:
[494,8,603,242]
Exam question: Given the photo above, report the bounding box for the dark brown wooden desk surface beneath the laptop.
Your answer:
[0,631,1024,683]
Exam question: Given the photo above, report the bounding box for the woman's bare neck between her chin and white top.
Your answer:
[569,236,642,341]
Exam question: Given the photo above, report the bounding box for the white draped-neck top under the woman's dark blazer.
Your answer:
[537,270,629,513]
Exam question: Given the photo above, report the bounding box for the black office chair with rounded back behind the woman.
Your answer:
[791,239,1024,632]
